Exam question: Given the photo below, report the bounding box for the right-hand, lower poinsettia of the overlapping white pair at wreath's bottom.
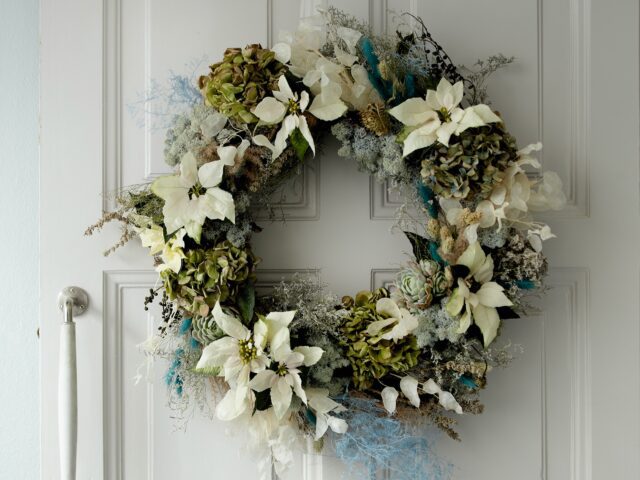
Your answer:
[249,327,323,418]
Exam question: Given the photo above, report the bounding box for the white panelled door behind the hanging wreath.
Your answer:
[40,0,640,480]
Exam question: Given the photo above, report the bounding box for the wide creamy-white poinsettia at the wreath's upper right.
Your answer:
[389,78,502,157]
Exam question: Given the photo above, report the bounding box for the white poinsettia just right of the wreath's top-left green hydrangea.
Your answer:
[253,75,316,159]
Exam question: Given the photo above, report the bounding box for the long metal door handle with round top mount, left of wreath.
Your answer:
[58,287,89,480]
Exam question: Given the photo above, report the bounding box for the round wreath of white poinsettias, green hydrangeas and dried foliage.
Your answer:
[90,9,565,478]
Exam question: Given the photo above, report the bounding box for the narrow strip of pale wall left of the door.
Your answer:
[0,0,40,480]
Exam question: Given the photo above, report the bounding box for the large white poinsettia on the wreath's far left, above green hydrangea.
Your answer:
[151,152,235,243]
